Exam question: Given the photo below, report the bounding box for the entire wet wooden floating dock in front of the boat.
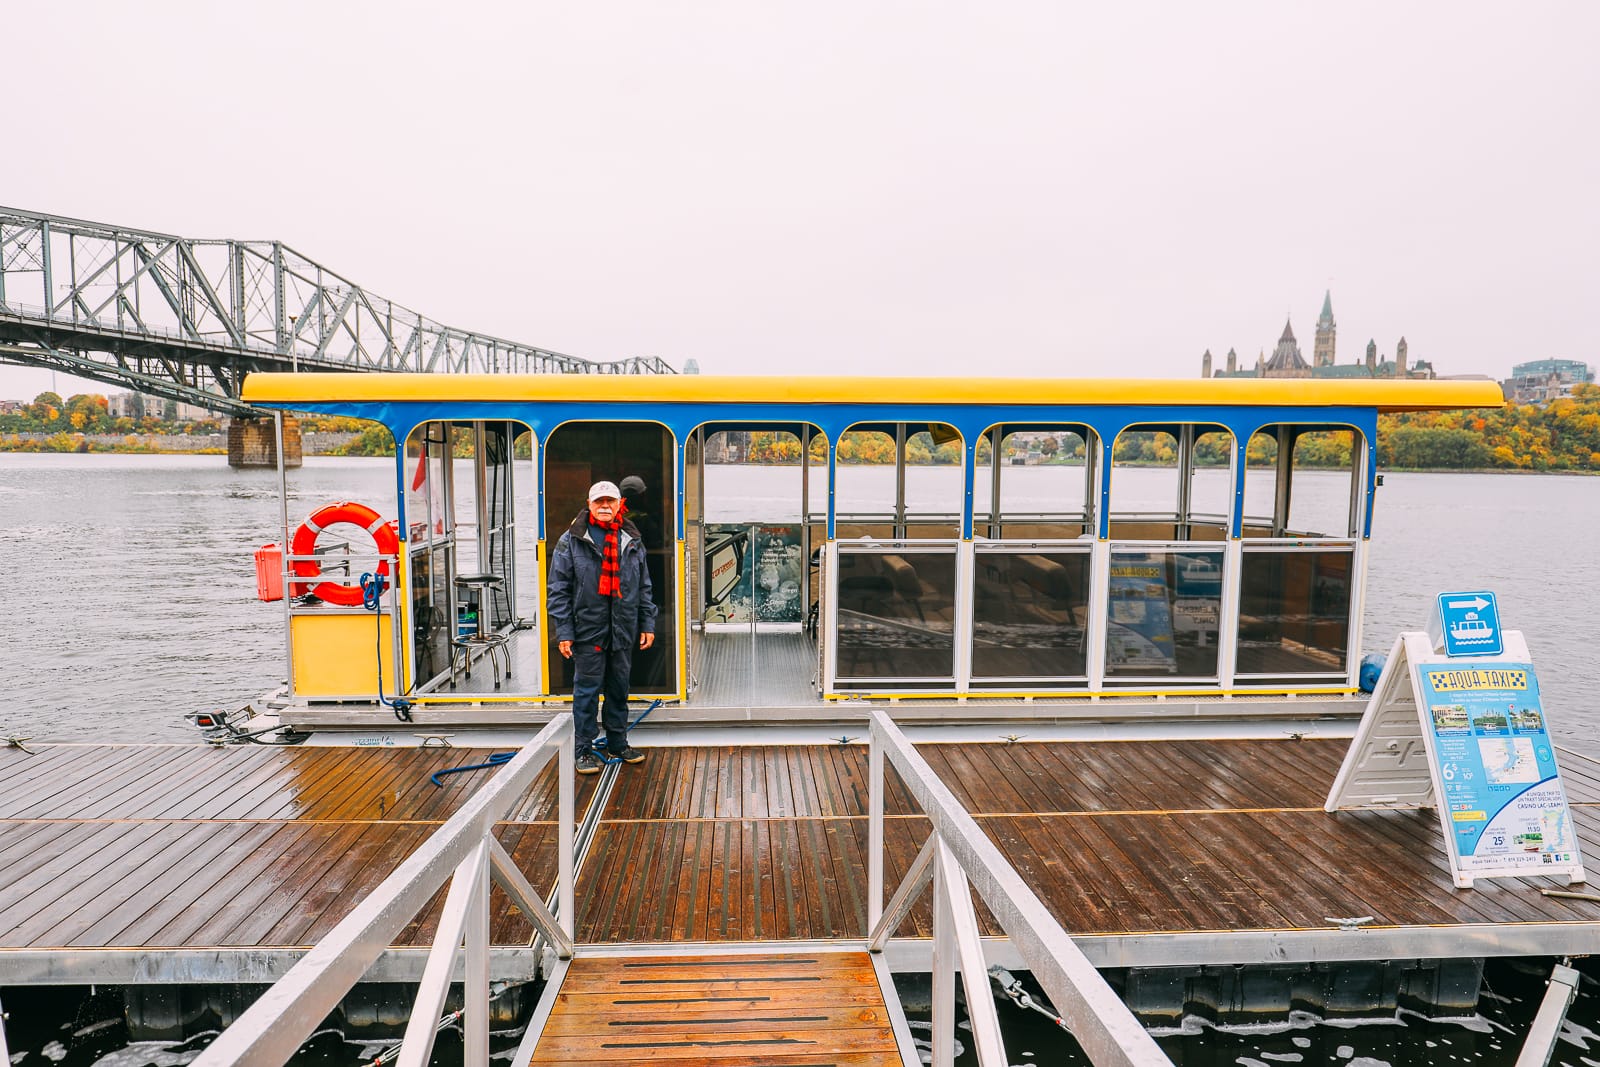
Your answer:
[0,736,1600,984]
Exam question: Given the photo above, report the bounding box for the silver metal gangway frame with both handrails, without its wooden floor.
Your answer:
[194,709,1171,1067]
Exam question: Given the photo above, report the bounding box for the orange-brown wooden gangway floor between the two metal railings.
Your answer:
[533,952,901,1067]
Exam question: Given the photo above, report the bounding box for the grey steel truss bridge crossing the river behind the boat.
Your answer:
[0,206,675,416]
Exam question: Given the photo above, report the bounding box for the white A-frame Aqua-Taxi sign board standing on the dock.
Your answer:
[1323,630,1584,888]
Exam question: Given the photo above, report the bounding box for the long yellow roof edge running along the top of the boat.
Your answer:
[243,373,1504,411]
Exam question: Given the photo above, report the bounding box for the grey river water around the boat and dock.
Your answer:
[0,454,1600,1067]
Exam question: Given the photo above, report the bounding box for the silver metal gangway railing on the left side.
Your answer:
[194,715,576,1067]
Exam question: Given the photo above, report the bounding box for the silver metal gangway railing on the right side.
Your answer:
[867,709,1171,1067]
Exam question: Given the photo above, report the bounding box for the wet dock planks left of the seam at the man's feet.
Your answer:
[0,745,594,950]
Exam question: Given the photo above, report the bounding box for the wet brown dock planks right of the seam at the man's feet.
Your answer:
[578,736,1600,942]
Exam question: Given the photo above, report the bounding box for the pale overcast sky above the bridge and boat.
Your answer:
[0,0,1600,397]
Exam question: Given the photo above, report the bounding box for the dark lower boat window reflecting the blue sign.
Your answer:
[1106,545,1222,685]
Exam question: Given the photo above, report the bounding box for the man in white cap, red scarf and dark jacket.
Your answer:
[546,482,656,774]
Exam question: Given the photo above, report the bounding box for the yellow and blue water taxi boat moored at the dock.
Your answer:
[228,374,1498,737]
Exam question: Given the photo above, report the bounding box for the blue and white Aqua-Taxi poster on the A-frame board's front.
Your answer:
[1416,661,1581,877]
